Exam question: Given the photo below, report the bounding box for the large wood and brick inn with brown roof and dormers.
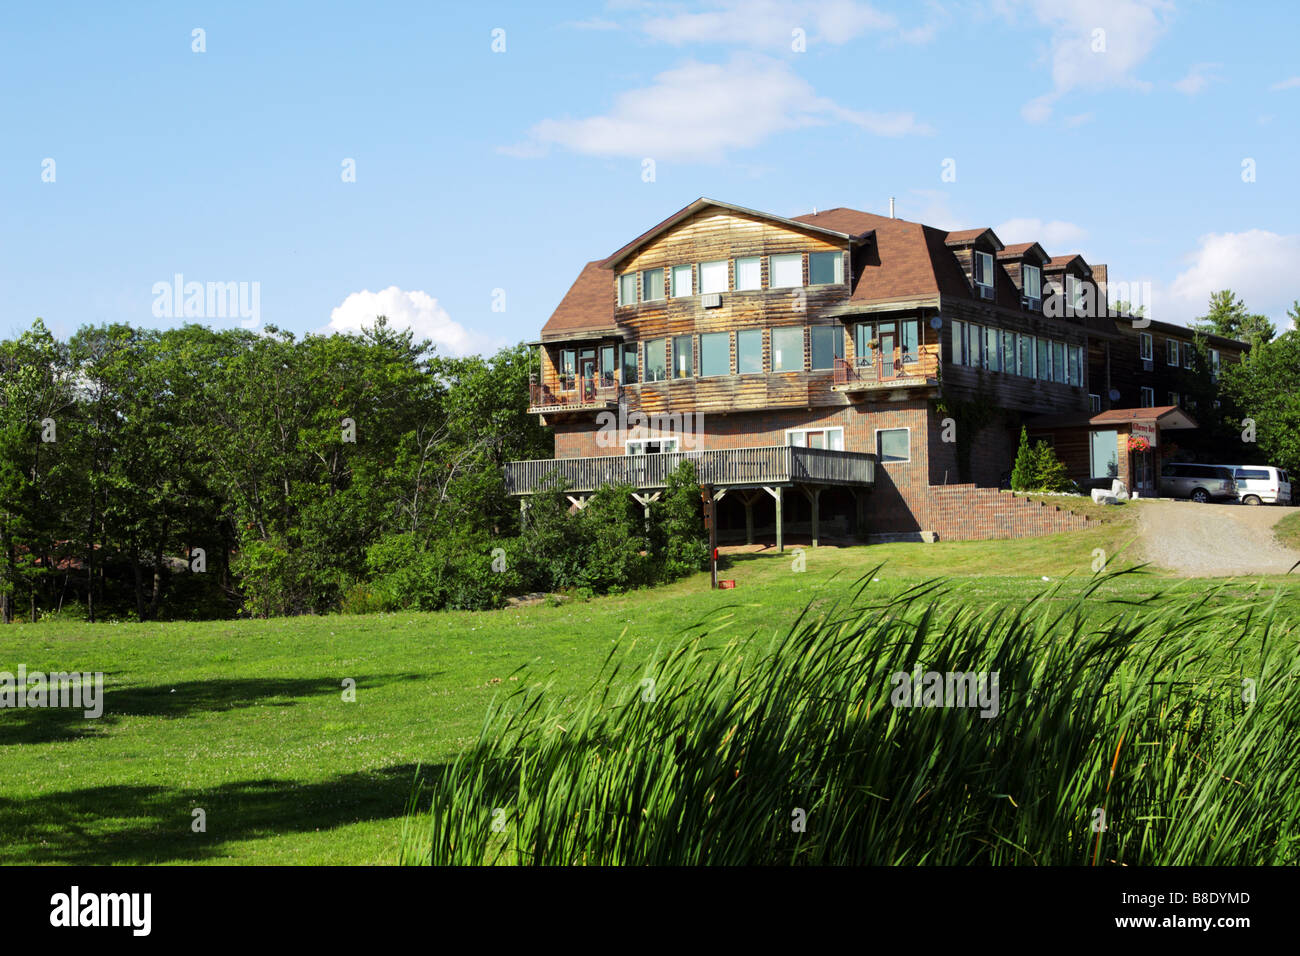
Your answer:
[507,199,1244,540]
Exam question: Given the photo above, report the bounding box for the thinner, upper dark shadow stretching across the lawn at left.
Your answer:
[0,671,441,749]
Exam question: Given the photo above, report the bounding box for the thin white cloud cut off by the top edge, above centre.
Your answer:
[641,0,915,49]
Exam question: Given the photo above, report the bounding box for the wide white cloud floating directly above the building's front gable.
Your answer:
[501,53,932,163]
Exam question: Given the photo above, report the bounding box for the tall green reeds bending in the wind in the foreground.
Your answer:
[404,578,1300,865]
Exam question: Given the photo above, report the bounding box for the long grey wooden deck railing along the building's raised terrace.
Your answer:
[506,445,876,494]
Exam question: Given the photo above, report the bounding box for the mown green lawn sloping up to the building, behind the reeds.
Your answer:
[0,520,1297,864]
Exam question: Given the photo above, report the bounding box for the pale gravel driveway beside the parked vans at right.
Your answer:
[1139,501,1300,578]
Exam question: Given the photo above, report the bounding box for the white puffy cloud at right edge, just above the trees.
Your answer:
[1157,229,1300,325]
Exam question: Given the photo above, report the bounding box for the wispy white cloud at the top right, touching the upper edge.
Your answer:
[1001,0,1173,124]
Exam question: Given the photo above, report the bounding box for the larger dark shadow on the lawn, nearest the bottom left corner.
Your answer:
[0,763,437,865]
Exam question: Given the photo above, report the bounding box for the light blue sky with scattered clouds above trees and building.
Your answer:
[0,0,1300,352]
